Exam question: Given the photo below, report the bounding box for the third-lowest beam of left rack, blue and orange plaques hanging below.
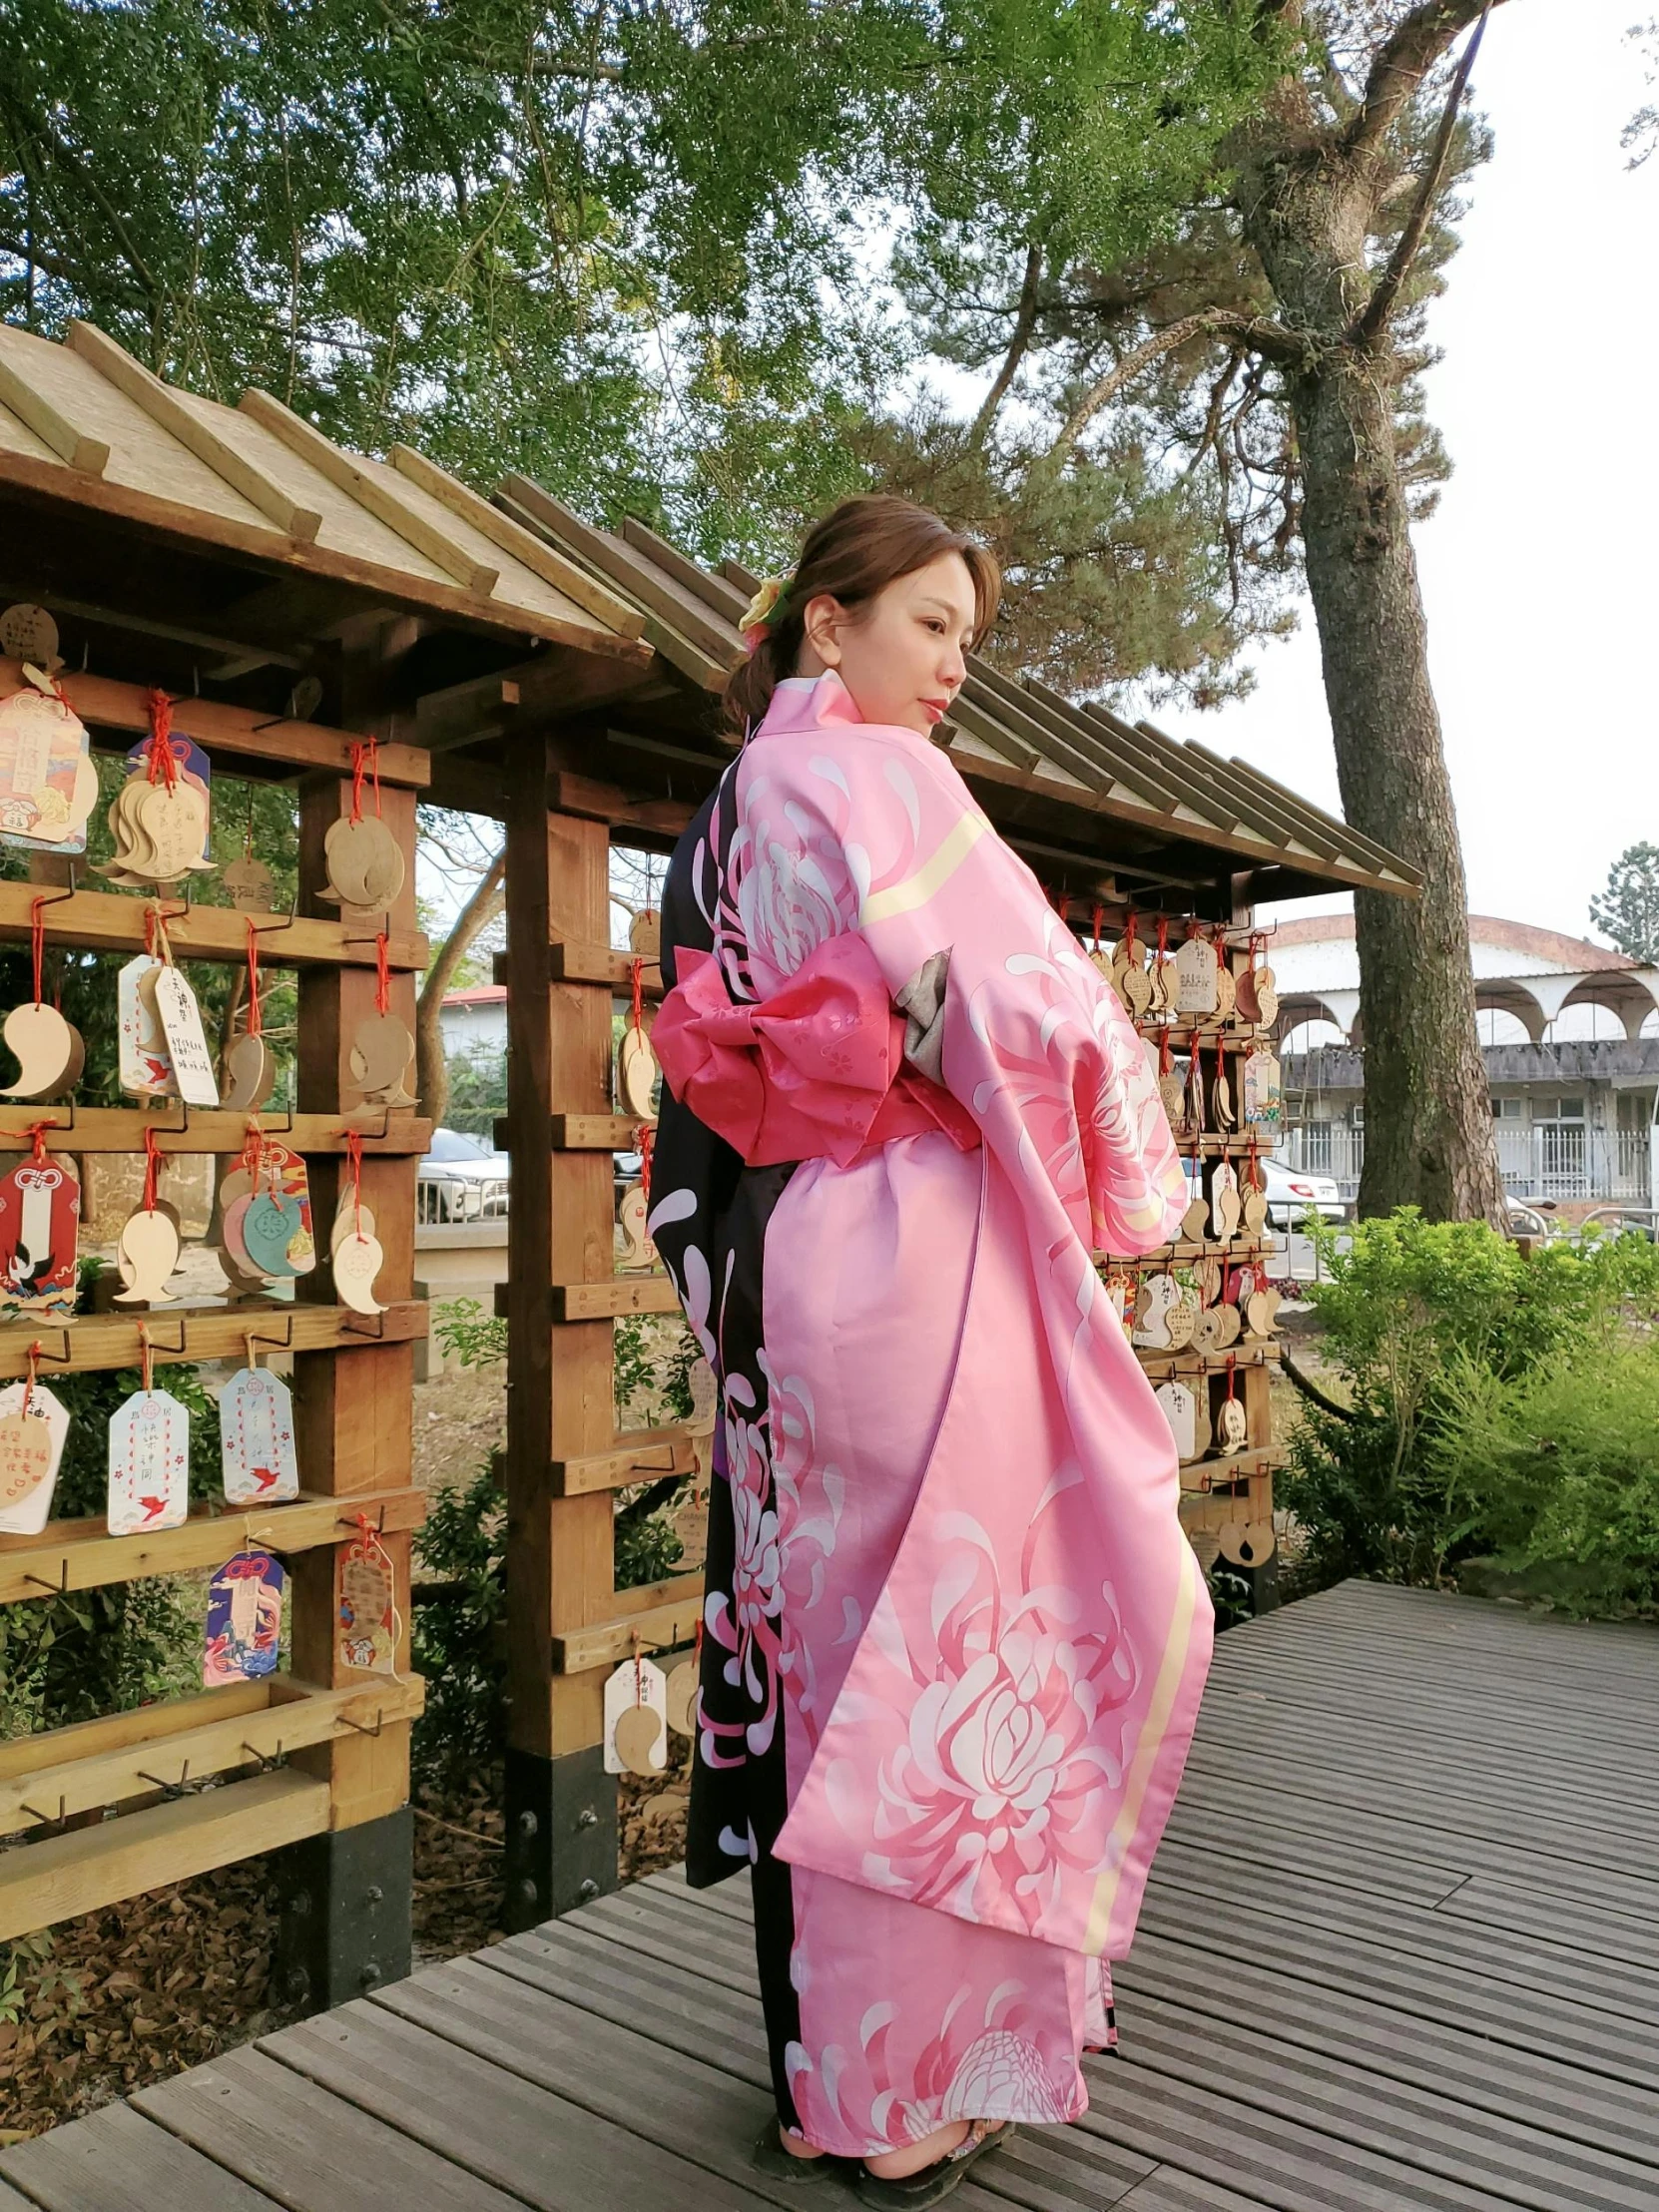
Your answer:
[0,1486,427,1606]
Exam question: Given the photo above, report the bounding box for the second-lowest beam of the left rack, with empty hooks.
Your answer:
[0,1675,424,1831]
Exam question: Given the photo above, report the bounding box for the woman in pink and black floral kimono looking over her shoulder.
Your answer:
[651,498,1210,2205]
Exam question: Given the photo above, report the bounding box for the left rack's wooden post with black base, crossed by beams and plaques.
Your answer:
[278,628,416,2010]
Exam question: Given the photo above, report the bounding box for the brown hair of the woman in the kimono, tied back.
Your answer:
[726,491,1002,737]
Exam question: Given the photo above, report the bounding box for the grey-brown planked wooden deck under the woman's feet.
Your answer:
[0,1584,1659,2212]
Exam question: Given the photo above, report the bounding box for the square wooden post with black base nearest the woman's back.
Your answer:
[506,737,617,1929]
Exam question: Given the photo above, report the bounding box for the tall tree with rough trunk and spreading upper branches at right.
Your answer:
[909,0,1502,1221]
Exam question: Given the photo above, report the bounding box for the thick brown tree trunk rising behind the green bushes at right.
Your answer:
[1294,345,1504,1226]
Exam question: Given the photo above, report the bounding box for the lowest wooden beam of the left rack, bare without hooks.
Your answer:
[0,1768,329,1942]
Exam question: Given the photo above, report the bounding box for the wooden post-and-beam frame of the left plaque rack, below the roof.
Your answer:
[0,694,431,2006]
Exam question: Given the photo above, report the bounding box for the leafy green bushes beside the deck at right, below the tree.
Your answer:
[1281,1208,1659,1608]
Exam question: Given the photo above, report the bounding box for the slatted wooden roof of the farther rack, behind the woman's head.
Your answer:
[498,475,1422,898]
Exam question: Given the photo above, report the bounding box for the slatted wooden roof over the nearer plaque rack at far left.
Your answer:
[0,323,651,664]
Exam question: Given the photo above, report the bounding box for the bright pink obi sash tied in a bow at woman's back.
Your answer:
[651,933,980,1168]
